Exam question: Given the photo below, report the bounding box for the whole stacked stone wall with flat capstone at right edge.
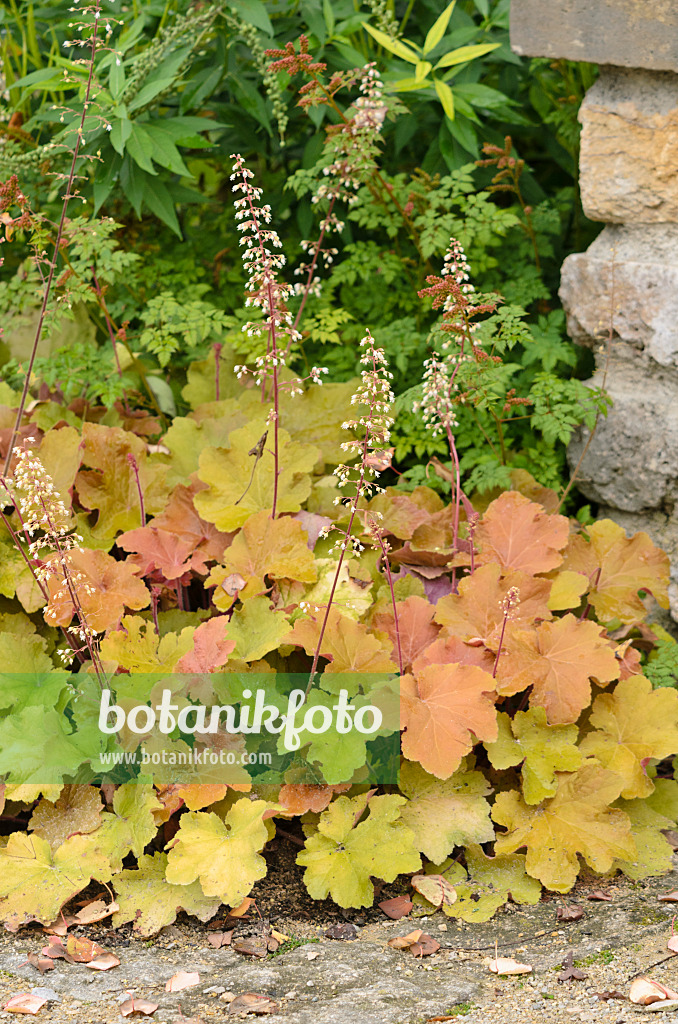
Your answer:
[511,0,678,621]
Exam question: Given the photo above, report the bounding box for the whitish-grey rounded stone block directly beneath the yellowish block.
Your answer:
[560,226,678,370]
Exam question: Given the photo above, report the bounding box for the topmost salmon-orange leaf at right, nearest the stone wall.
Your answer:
[475,490,569,574]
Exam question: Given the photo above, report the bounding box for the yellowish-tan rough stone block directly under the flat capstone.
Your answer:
[580,68,678,223]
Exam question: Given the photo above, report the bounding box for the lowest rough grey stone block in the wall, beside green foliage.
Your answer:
[567,357,678,516]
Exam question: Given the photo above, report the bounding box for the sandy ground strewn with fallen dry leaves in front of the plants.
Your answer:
[0,840,678,1024]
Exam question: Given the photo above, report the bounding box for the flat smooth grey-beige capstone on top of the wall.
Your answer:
[511,0,678,72]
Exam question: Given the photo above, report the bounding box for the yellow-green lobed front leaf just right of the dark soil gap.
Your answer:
[297,795,421,906]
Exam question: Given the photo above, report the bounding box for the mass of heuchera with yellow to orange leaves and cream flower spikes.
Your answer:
[0,19,678,935]
